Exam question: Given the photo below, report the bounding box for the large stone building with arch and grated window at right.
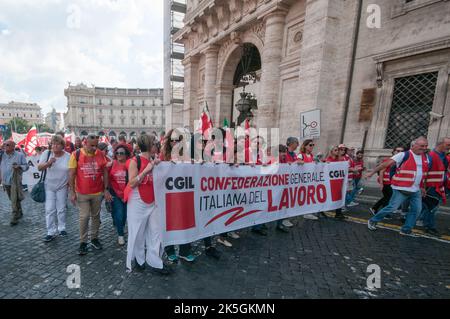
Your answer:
[170,0,450,170]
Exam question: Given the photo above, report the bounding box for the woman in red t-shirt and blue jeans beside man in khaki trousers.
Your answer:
[109,144,131,246]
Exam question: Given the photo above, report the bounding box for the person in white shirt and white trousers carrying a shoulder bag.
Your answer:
[38,135,70,242]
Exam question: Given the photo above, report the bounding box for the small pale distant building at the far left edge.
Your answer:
[0,102,42,125]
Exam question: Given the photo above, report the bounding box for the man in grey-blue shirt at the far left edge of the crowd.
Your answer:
[0,140,28,226]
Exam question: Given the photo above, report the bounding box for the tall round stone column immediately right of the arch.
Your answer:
[256,9,287,128]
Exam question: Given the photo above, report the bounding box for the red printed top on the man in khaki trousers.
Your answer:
[75,150,106,195]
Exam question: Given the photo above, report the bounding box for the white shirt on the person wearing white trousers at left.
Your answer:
[39,150,70,191]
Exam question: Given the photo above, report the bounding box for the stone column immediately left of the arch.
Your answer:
[204,45,219,124]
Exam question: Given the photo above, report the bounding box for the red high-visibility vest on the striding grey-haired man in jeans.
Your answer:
[391,151,429,187]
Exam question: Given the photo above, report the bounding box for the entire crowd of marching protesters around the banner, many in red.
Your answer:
[0,129,450,275]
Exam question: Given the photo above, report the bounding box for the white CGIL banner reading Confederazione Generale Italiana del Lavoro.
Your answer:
[153,162,348,246]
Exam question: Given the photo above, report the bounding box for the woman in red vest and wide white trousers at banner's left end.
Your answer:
[124,134,171,275]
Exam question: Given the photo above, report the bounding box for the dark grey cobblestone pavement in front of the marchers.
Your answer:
[0,192,450,299]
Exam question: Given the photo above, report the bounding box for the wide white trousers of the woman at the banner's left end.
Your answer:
[127,189,163,270]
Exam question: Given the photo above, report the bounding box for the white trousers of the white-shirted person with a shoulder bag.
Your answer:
[45,187,68,236]
